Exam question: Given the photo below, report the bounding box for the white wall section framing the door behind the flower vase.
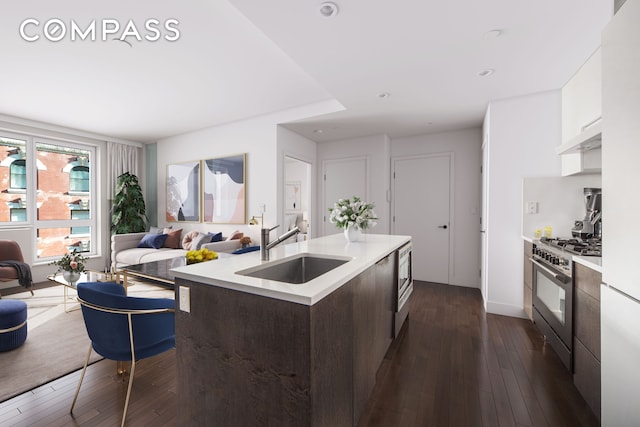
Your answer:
[314,135,391,234]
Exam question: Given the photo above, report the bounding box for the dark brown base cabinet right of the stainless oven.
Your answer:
[573,263,602,419]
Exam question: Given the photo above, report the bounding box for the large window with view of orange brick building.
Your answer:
[0,134,99,262]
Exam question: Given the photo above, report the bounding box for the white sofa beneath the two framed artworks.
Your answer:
[111,232,242,270]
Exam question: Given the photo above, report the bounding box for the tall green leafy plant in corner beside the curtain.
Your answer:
[111,172,147,234]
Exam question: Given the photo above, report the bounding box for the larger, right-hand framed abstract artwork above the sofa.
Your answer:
[202,154,246,224]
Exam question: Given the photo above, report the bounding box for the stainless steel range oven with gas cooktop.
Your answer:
[531,239,574,372]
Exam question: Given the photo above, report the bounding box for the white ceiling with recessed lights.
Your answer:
[0,0,613,142]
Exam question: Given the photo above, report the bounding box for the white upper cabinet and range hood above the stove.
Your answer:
[556,48,602,176]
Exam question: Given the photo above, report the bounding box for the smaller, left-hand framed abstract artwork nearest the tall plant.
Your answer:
[166,160,200,222]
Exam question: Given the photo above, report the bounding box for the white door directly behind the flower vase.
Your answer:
[322,157,369,236]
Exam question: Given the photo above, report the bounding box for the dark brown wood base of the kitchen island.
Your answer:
[176,252,396,427]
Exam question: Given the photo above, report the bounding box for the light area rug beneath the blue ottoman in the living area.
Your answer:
[0,284,173,402]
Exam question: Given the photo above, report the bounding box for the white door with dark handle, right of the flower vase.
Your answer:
[392,154,451,284]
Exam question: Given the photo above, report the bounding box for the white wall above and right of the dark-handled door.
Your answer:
[391,128,482,287]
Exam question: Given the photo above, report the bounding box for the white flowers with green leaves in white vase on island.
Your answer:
[329,196,378,242]
